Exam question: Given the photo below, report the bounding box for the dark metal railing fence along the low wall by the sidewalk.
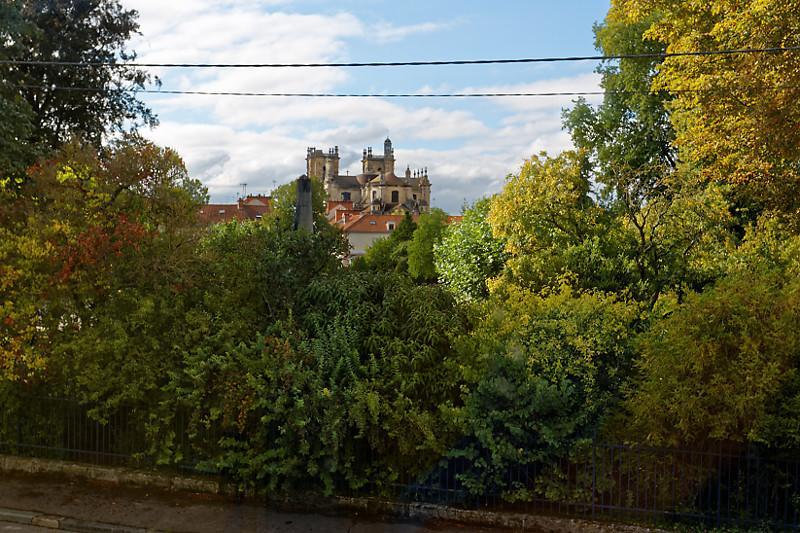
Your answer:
[0,397,800,530]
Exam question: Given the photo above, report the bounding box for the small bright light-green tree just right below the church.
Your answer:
[434,198,507,300]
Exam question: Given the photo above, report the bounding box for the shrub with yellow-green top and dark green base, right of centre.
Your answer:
[455,286,639,499]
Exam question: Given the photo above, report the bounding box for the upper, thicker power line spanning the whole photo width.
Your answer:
[0,46,800,68]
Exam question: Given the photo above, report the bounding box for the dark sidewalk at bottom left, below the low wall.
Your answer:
[0,473,506,533]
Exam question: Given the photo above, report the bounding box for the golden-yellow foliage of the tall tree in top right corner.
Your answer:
[609,0,800,218]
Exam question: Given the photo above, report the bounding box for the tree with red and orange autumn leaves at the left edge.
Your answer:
[0,137,204,388]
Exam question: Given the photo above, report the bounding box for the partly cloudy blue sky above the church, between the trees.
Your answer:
[128,0,609,213]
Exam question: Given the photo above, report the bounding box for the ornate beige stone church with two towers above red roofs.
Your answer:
[306,138,431,214]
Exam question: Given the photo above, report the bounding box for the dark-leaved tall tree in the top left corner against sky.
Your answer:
[0,0,157,148]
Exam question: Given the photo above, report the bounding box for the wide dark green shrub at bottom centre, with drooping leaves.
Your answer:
[167,271,467,492]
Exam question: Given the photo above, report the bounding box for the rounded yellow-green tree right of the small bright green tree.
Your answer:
[489,151,627,290]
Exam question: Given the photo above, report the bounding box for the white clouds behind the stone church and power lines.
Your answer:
[126,0,599,211]
